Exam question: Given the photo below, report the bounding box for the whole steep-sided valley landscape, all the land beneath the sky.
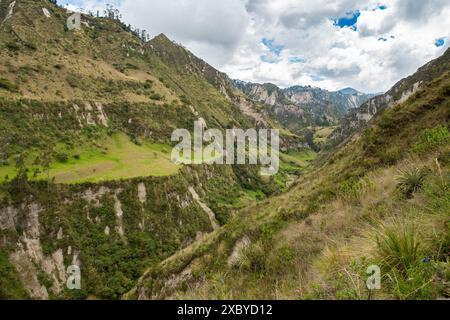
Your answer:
[0,0,450,300]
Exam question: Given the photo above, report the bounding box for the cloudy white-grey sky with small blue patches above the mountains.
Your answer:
[59,0,450,92]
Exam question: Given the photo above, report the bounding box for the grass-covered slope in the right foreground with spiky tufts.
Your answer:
[126,54,450,299]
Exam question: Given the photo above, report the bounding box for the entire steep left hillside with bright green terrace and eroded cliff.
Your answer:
[0,0,308,299]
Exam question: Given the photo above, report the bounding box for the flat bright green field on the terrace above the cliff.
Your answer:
[0,134,180,184]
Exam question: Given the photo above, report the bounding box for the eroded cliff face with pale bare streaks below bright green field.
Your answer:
[0,167,239,299]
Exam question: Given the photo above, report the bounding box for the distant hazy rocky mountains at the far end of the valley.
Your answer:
[235,81,373,147]
